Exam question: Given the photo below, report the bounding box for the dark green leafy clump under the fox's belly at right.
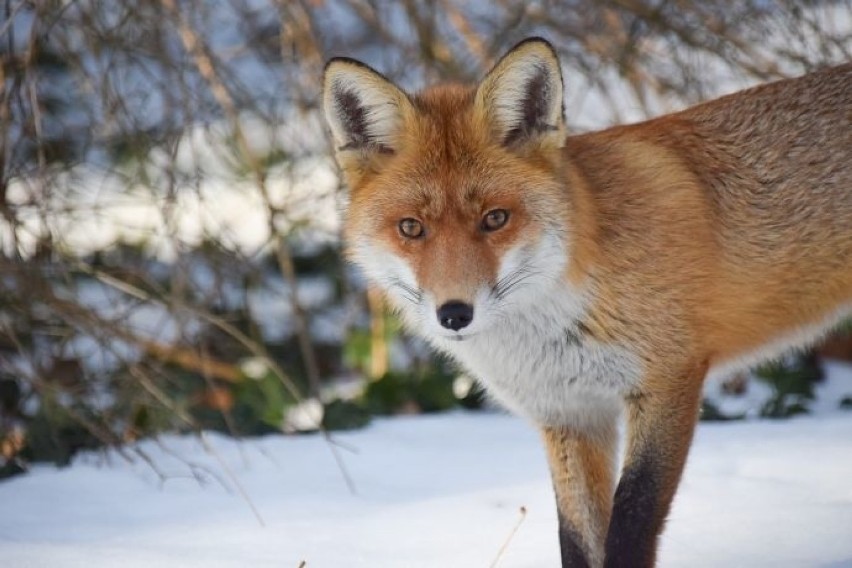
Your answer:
[755,355,823,418]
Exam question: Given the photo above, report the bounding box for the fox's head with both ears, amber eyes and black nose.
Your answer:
[323,38,571,340]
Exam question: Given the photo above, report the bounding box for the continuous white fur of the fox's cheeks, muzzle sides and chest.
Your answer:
[354,226,641,432]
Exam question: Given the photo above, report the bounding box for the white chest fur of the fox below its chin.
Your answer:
[432,292,641,428]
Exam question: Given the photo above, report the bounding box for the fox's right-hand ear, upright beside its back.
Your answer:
[474,38,564,147]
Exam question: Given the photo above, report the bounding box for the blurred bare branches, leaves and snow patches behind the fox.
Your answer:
[0,0,852,477]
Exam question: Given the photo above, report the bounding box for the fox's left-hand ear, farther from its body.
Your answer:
[323,57,411,157]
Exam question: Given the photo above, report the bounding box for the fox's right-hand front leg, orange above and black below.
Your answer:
[604,365,706,568]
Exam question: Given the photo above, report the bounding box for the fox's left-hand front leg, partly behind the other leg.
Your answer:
[543,417,618,568]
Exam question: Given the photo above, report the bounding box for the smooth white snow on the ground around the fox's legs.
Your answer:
[0,364,852,568]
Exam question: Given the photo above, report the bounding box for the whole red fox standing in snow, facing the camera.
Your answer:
[323,38,852,567]
